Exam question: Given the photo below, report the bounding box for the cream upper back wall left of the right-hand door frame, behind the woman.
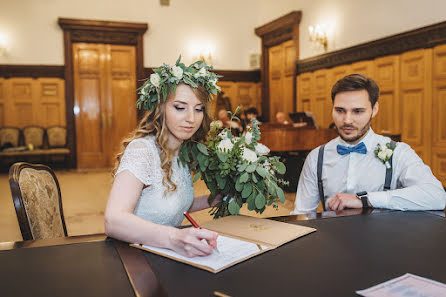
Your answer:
[0,0,260,69]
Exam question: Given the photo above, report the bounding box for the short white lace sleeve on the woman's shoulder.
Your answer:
[116,139,158,185]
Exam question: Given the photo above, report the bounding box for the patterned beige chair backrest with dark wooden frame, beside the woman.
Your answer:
[9,162,67,240]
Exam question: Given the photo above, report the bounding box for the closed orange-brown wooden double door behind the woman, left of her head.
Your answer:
[73,43,136,168]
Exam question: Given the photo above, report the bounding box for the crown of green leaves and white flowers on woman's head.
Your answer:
[136,55,222,110]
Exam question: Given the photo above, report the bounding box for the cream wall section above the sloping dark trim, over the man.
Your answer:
[296,0,446,59]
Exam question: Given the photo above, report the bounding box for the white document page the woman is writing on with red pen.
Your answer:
[138,235,269,272]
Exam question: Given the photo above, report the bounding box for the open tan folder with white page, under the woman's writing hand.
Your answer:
[131,216,316,273]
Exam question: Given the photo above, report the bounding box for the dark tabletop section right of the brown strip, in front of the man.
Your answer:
[145,211,446,297]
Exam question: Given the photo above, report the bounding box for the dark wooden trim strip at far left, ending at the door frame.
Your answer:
[0,65,65,78]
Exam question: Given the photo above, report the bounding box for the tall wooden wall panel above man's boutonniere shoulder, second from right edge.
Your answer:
[400,49,432,164]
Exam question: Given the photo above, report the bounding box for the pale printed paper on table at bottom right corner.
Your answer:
[356,273,446,297]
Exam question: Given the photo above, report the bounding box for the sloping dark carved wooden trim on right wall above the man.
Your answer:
[296,22,446,74]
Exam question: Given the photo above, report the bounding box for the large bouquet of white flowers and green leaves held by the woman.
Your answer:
[179,107,288,218]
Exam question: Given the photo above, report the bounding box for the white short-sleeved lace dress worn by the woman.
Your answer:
[116,136,194,226]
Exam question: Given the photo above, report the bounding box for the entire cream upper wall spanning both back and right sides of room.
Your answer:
[0,0,446,70]
